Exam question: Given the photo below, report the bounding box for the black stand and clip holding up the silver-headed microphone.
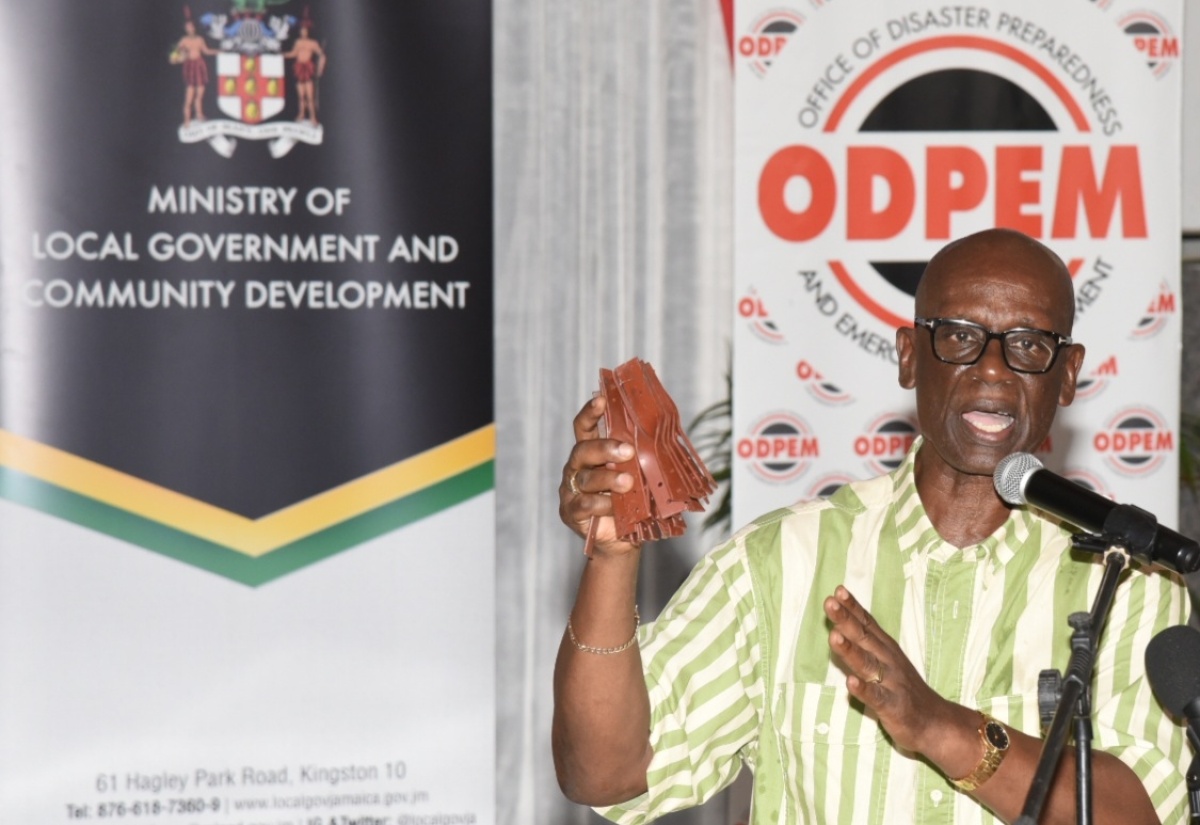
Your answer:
[1014,505,1156,825]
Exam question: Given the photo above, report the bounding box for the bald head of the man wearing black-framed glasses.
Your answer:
[896,229,1084,476]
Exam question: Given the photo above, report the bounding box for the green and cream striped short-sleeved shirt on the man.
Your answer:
[600,446,1188,825]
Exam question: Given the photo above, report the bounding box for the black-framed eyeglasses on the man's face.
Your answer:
[913,318,1073,373]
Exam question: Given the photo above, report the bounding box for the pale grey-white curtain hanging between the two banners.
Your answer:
[493,0,734,825]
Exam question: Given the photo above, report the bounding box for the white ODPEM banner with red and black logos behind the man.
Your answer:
[733,0,1182,525]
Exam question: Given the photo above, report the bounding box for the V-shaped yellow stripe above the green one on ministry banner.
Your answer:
[0,424,496,558]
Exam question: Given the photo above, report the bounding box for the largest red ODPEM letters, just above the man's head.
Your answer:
[758,144,1147,242]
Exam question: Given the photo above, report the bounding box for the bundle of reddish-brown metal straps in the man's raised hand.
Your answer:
[600,359,716,542]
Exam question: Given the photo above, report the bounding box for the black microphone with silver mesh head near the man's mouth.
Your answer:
[992,452,1200,573]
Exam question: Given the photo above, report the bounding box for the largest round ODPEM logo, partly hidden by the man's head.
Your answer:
[757,29,1148,330]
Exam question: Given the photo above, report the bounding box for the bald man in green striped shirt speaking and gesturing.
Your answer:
[553,229,1187,825]
